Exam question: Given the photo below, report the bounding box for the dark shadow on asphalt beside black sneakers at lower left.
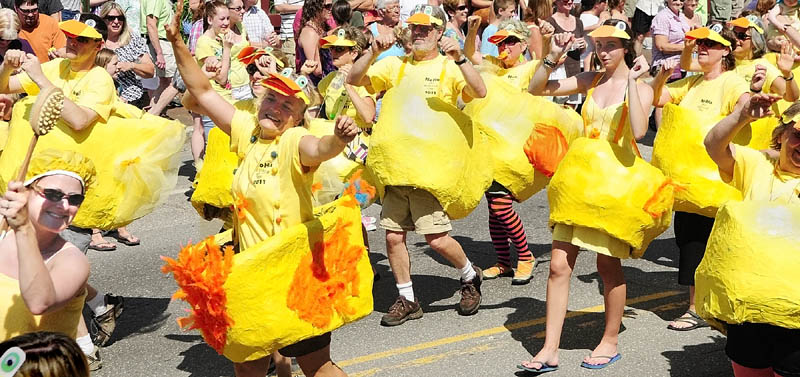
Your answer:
[97,297,170,346]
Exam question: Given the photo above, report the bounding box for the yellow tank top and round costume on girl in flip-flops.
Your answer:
[547,75,674,258]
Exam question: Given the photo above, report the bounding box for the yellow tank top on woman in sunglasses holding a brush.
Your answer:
[0,273,86,341]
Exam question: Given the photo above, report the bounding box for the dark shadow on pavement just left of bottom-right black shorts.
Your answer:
[661,335,733,377]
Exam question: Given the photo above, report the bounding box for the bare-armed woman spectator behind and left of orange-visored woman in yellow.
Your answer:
[295,0,336,85]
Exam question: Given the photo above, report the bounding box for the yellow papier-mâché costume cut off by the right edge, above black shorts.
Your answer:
[695,201,800,329]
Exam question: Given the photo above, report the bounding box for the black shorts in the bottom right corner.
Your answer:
[725,322,800,377]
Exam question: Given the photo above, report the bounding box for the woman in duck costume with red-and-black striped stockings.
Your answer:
[464,16,582,285]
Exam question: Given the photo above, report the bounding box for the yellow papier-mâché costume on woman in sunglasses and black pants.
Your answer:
[653,104,742,217]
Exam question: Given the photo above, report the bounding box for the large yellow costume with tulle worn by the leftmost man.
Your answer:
[0,96,186,229]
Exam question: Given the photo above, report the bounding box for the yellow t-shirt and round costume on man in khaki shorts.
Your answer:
[367,56,492,219]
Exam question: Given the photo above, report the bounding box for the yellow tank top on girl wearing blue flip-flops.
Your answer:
[581,75,641,157]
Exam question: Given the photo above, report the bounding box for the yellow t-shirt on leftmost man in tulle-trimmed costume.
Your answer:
[15,59,117,120]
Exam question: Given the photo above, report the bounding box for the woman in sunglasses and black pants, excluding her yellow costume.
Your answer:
[651,24,750,331]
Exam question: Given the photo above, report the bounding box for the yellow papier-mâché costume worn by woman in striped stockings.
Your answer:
[464,72,583,202]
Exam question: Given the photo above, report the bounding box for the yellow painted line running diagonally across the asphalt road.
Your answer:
[336,291,684,367]
